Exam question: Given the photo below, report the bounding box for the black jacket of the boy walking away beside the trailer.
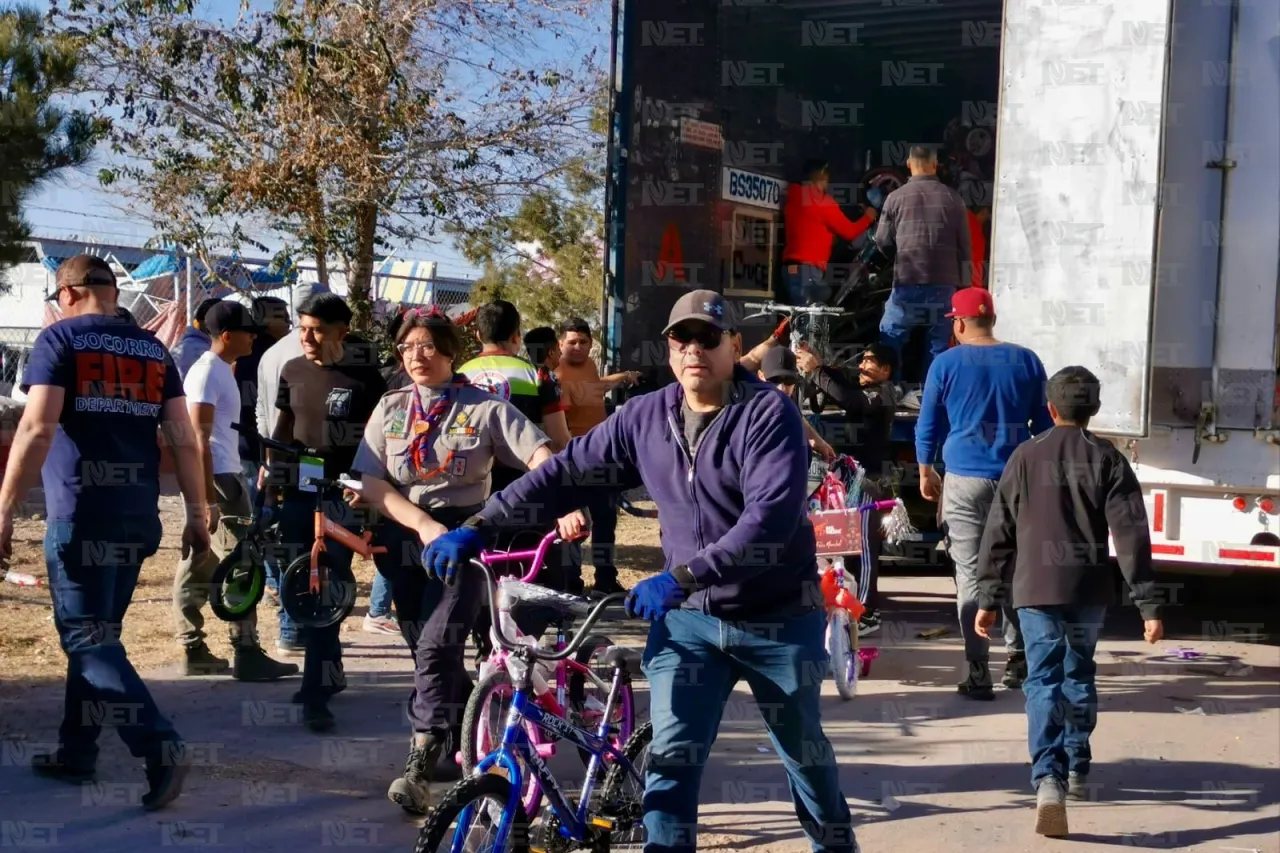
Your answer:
[978,427,1160,619]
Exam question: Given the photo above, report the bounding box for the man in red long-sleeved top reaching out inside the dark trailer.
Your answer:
[782,160,876,305]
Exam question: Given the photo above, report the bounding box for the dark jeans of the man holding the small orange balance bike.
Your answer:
[280,492,358,704]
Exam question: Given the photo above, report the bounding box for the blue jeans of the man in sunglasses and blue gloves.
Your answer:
[644,610,854,853]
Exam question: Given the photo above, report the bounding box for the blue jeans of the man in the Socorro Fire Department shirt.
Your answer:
[45,515,178,768]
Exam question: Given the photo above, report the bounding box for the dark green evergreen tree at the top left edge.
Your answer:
[0,2,102,288]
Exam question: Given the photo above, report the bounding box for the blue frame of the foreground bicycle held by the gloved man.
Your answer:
[468,661,644,853]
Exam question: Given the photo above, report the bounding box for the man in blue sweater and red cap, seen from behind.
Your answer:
[915,287,1053,701]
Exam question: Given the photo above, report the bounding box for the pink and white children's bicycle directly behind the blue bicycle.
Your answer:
[457,532,635,816]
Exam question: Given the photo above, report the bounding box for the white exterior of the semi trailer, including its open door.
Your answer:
[991,0,1280,570]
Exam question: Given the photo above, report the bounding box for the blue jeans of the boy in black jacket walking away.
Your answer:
[1018,606,1107,789]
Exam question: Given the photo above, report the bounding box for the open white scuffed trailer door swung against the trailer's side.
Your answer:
[991,0,1171,437]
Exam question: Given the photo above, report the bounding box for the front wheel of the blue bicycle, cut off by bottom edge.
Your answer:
[413,774,529,853]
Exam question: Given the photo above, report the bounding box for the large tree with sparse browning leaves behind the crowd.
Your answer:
[59,0,599,327]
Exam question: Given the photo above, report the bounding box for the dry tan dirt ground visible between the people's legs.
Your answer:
[0,497,662,684]
